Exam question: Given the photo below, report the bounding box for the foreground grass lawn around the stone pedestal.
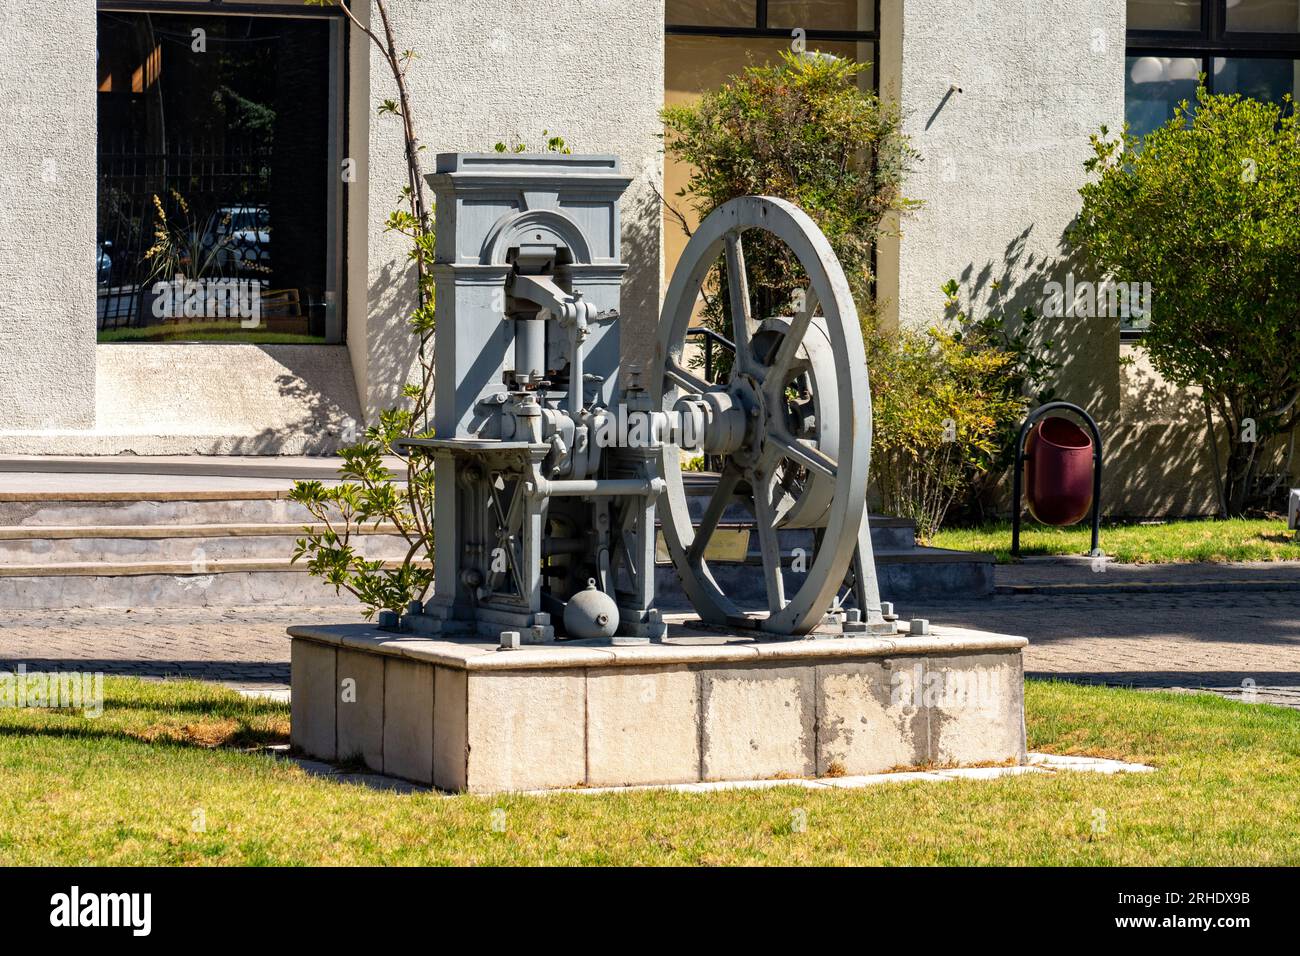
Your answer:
[0,679,1300,865]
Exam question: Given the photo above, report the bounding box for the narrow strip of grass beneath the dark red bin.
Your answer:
[931,519,1300,564]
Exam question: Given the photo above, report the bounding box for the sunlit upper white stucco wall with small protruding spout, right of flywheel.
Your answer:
[881,0,1126,340]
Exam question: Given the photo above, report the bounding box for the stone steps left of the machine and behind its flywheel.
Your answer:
[0,459,993,609]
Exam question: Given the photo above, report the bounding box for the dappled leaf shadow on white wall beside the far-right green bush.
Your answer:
[958,226,1222,516]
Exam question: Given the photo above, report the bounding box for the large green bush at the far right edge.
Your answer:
[1071,87,1300,515]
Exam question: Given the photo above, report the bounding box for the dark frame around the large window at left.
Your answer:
[95,0,352,347]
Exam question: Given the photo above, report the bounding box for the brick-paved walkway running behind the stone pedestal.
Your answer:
[0,564,1300,706]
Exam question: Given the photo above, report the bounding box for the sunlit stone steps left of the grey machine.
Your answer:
[0,468,407,610]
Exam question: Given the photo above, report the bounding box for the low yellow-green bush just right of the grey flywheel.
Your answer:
[867,326,1028,542]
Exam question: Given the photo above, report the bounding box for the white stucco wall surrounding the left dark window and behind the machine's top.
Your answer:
[0,0,663,454]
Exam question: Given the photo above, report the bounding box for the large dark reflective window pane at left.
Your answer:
[98,3,343,342]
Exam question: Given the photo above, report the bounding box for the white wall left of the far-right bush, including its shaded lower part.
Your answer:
[879,0,1279,515]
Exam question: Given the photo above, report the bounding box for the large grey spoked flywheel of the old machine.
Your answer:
[650,196,871,635]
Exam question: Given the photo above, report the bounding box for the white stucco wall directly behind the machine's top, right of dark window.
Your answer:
[347,0,664,415]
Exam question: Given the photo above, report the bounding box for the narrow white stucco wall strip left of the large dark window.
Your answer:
[0,0,95,429]
